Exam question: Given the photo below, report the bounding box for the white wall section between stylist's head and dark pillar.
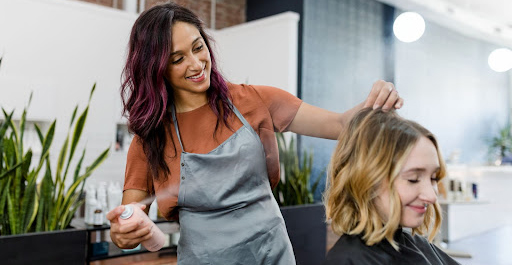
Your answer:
[212,12,299,95]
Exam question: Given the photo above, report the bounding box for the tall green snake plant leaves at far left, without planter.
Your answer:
[0,81,110,235]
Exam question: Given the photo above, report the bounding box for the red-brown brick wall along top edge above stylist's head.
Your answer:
[74,0,247,29]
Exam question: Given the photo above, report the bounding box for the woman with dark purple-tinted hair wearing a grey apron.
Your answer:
[107,3,403,265]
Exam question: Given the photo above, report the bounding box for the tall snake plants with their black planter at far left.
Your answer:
[0,58,110,264]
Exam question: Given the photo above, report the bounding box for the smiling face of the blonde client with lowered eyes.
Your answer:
[376,137,439,228]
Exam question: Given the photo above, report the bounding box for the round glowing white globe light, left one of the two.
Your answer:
[393,12,425,42]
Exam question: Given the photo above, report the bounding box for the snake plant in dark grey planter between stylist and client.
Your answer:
[273,133,327,265]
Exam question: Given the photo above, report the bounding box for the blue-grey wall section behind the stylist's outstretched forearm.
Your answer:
[301,0,386,200]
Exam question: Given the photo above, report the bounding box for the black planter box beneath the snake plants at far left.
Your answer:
[0,229,87,265]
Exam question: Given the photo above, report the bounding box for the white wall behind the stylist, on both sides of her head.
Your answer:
[0,0,298,187]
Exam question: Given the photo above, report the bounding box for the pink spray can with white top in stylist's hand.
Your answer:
[119,204,165,252]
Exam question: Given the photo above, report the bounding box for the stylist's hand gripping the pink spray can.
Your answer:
[107,203,152,249]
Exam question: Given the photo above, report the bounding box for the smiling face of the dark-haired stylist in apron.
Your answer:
[166,22,211,95]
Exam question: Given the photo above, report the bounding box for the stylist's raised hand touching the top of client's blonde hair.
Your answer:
[364,80,404,111]
